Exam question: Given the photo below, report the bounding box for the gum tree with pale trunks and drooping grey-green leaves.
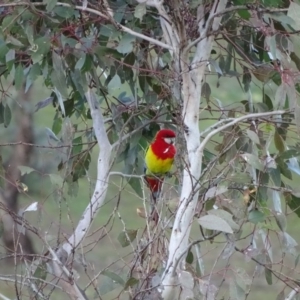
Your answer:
[0,0,300,299]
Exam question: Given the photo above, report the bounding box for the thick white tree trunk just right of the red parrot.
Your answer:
[162,0,226,299]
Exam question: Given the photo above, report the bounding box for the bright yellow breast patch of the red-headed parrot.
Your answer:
[145,147,174,175]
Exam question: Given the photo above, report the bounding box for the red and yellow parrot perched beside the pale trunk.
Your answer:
[144,129,176,218]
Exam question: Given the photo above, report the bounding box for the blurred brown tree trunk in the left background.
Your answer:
[0,85,35,259]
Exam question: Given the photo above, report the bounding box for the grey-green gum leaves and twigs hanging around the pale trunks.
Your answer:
[0,0,300,299]
